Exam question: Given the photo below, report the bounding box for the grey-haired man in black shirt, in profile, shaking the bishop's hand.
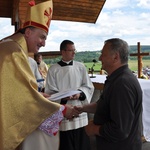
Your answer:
[76,38,142,150]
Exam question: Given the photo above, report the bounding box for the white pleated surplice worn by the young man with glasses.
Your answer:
[45,61,94,131]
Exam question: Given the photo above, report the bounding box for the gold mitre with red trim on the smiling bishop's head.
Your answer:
[23,0,53,33]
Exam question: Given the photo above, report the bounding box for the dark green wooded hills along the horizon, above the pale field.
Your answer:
[44,45,150,64]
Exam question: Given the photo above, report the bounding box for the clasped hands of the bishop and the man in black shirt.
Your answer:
[64,105,83,120]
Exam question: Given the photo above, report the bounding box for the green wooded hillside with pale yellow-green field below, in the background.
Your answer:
[44,45,150,71]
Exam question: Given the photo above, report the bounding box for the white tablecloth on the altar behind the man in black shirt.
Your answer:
[91,75,150,141]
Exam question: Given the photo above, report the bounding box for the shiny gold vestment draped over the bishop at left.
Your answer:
[0,33,60,150]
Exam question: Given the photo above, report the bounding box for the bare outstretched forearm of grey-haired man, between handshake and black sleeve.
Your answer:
[83,102,97,113]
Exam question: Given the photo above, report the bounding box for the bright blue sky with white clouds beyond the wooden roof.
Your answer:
[0,0,150,52]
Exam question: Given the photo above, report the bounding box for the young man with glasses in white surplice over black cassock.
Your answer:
[45,40,94,150]
